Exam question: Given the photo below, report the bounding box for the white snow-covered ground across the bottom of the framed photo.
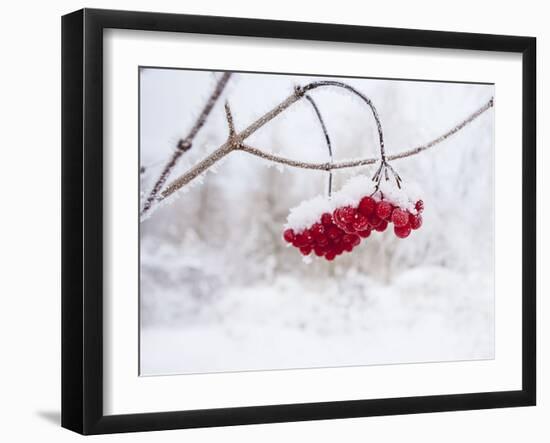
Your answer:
[141,268,494,375]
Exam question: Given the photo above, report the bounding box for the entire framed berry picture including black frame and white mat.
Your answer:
[61,8,537,435]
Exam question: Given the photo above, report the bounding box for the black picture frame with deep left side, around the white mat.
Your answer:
[62,9,536,434]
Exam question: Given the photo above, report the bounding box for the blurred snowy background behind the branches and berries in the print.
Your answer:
[140,69,494,375]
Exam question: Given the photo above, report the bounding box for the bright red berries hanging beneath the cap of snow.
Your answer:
[283,197,424,261]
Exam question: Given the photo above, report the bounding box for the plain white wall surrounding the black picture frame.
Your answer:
[0,0,550,442]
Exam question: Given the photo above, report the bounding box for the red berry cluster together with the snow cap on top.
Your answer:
[283,176,424,261]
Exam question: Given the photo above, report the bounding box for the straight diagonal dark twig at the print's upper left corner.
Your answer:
[141,72,232,216]
